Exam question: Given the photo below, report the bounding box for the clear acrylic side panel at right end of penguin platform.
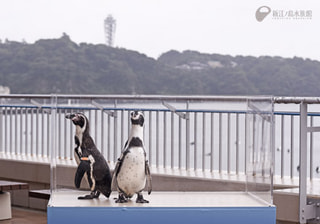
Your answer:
[246,97,274,204]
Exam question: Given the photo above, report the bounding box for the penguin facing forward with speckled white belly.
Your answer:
[112,111,152,203]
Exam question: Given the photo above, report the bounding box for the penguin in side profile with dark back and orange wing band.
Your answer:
[66,113,112,199]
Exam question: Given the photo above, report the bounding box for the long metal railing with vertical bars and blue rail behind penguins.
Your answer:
[0,95,320,179]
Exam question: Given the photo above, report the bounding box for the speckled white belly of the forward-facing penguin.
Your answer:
[117,147,146,197]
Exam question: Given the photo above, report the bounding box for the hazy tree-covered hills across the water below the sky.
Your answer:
[0,34,320,96]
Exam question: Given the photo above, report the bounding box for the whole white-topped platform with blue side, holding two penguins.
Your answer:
[48,191,276,224]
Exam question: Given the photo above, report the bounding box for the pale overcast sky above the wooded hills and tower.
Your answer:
[0,0,320,60]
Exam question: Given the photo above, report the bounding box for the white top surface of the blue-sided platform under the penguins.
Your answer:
[49,191,269,207]
